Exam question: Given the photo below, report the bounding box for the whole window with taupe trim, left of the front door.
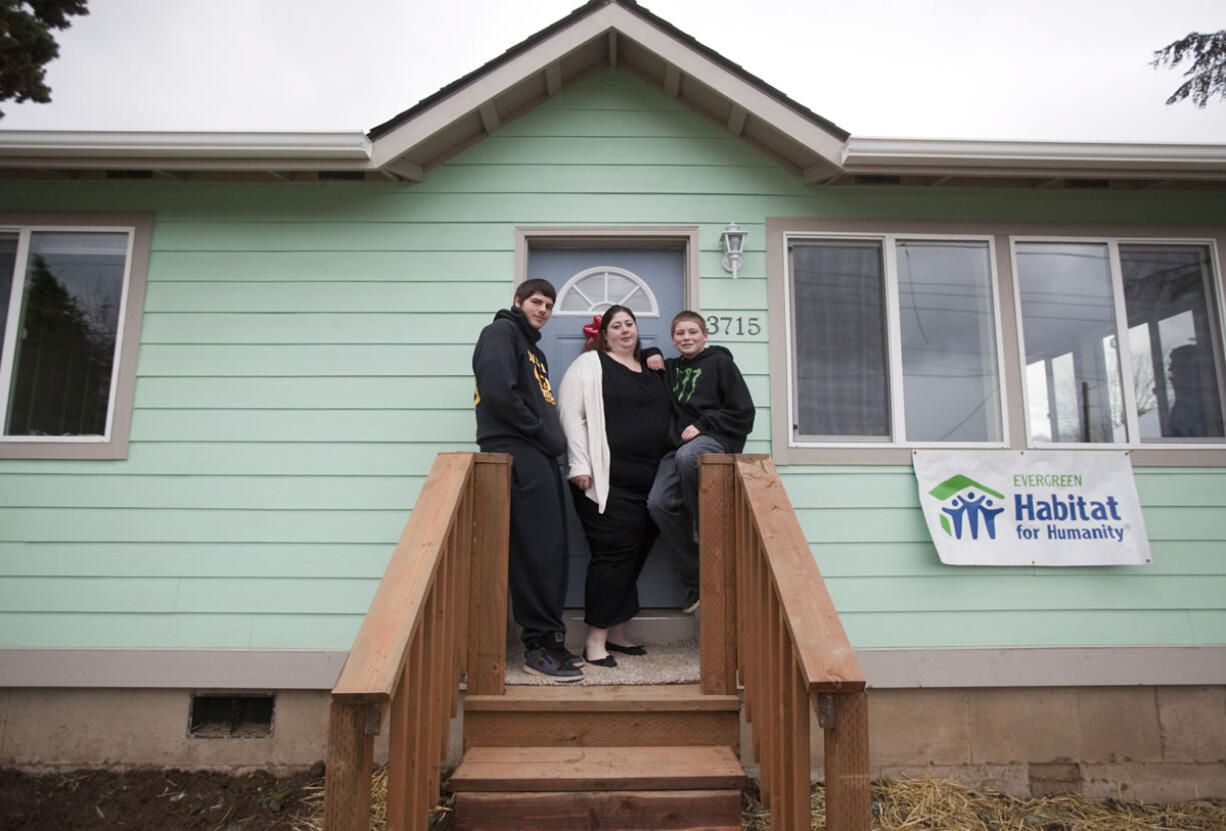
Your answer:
[0,217,150,458]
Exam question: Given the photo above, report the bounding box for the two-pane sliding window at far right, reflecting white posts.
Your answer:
[1014,240,1224,445]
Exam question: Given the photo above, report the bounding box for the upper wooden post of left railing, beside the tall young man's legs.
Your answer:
[467,453,511,695]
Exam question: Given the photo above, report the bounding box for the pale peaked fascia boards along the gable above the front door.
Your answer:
[373,5,843,167]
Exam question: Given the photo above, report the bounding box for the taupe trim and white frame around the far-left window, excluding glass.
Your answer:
[0,213,153,458]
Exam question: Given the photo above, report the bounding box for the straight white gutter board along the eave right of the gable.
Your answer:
[842,137,1226,178]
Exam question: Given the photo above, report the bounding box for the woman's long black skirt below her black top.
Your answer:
[571,485,657,629]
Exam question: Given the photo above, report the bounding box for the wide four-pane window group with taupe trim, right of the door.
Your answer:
[766,218,1226,465]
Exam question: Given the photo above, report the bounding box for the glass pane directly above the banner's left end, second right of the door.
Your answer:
[897,240,1002,441]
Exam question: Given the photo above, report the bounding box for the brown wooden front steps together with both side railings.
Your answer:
[324,453,870,831]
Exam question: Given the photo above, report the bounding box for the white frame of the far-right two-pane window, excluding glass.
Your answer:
[1009,234,1226,450]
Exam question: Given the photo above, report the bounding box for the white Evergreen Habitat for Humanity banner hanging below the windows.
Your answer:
[913,450,1150,565]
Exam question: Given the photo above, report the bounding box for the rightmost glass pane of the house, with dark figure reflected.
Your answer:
[1119,245,1224,440]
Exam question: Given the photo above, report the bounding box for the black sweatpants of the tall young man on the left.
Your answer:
[481,441,569,648]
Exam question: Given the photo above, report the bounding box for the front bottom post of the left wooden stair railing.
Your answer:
[324,699,379,831]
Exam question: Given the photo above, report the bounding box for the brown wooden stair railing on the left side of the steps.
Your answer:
[324,453,510,831]
